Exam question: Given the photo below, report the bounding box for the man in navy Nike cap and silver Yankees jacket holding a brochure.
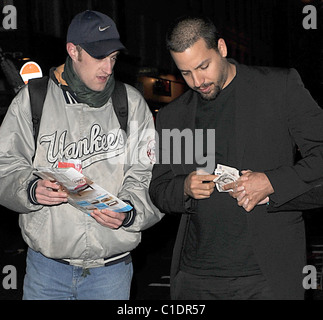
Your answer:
[0,11,162,300]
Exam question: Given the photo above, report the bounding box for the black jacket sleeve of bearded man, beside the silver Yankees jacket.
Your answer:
[149,110,197,214]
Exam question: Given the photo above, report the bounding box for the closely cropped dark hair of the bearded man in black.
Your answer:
[166,16,220,52]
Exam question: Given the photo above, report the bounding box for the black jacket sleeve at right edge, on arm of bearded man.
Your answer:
[265,69,323,206]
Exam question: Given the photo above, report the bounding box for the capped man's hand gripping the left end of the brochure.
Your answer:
[35,180,67,206]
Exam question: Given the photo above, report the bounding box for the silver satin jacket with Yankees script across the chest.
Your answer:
[0,69,162,268]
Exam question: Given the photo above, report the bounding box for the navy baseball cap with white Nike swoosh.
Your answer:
[67,10,125,59]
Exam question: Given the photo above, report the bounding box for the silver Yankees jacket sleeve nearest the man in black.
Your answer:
[118,91,163,232]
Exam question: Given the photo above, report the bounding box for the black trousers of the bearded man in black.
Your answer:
[172,271,275,300]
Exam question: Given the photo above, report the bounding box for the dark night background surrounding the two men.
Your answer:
[0,0,323,299]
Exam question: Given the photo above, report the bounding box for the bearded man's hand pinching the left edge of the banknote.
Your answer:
[184,171,217,200]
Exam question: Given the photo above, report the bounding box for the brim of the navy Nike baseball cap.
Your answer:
[80,39,126,59]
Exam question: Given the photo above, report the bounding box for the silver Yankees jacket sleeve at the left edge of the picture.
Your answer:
[0,87,42,213]
